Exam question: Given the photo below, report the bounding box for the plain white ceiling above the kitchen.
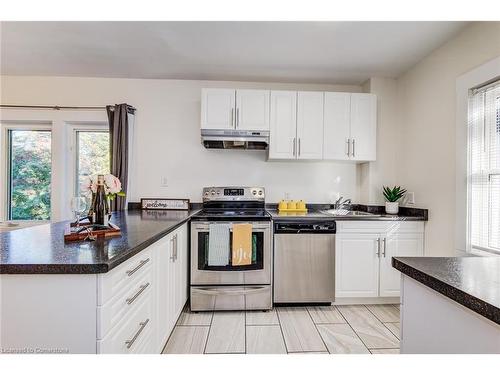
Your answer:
[0,22,466,84]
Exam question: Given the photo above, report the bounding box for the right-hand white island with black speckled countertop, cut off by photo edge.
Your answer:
[392,257,500,354]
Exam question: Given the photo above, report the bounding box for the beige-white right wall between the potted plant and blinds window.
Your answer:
[396,22,500,256]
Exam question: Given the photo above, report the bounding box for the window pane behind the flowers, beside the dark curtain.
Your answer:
[75,127,110,196]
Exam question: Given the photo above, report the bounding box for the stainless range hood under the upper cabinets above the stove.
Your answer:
[201,129,269,150]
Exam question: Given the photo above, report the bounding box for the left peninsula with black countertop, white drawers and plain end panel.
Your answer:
[0,210,195,353]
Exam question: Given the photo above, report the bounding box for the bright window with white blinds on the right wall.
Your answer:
[468,81,500,252]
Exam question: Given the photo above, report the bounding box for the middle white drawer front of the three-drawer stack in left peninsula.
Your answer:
[97,269,154,339]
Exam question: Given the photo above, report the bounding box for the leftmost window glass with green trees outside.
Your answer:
[7,129,52,220]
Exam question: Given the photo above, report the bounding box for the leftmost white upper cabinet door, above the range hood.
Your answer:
[201,89,235,129]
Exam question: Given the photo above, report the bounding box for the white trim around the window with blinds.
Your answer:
[455,56,500,255]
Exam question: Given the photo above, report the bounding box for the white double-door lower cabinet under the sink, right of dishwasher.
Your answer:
[335,221,424,298]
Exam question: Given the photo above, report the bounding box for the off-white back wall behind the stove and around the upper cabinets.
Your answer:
[1,76,361,202]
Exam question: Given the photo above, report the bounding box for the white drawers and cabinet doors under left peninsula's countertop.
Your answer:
[97,224,188,354]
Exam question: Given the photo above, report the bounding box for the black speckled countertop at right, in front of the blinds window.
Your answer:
[392,257,500,324]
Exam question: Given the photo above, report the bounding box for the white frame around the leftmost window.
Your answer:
[0,121,54,225]
